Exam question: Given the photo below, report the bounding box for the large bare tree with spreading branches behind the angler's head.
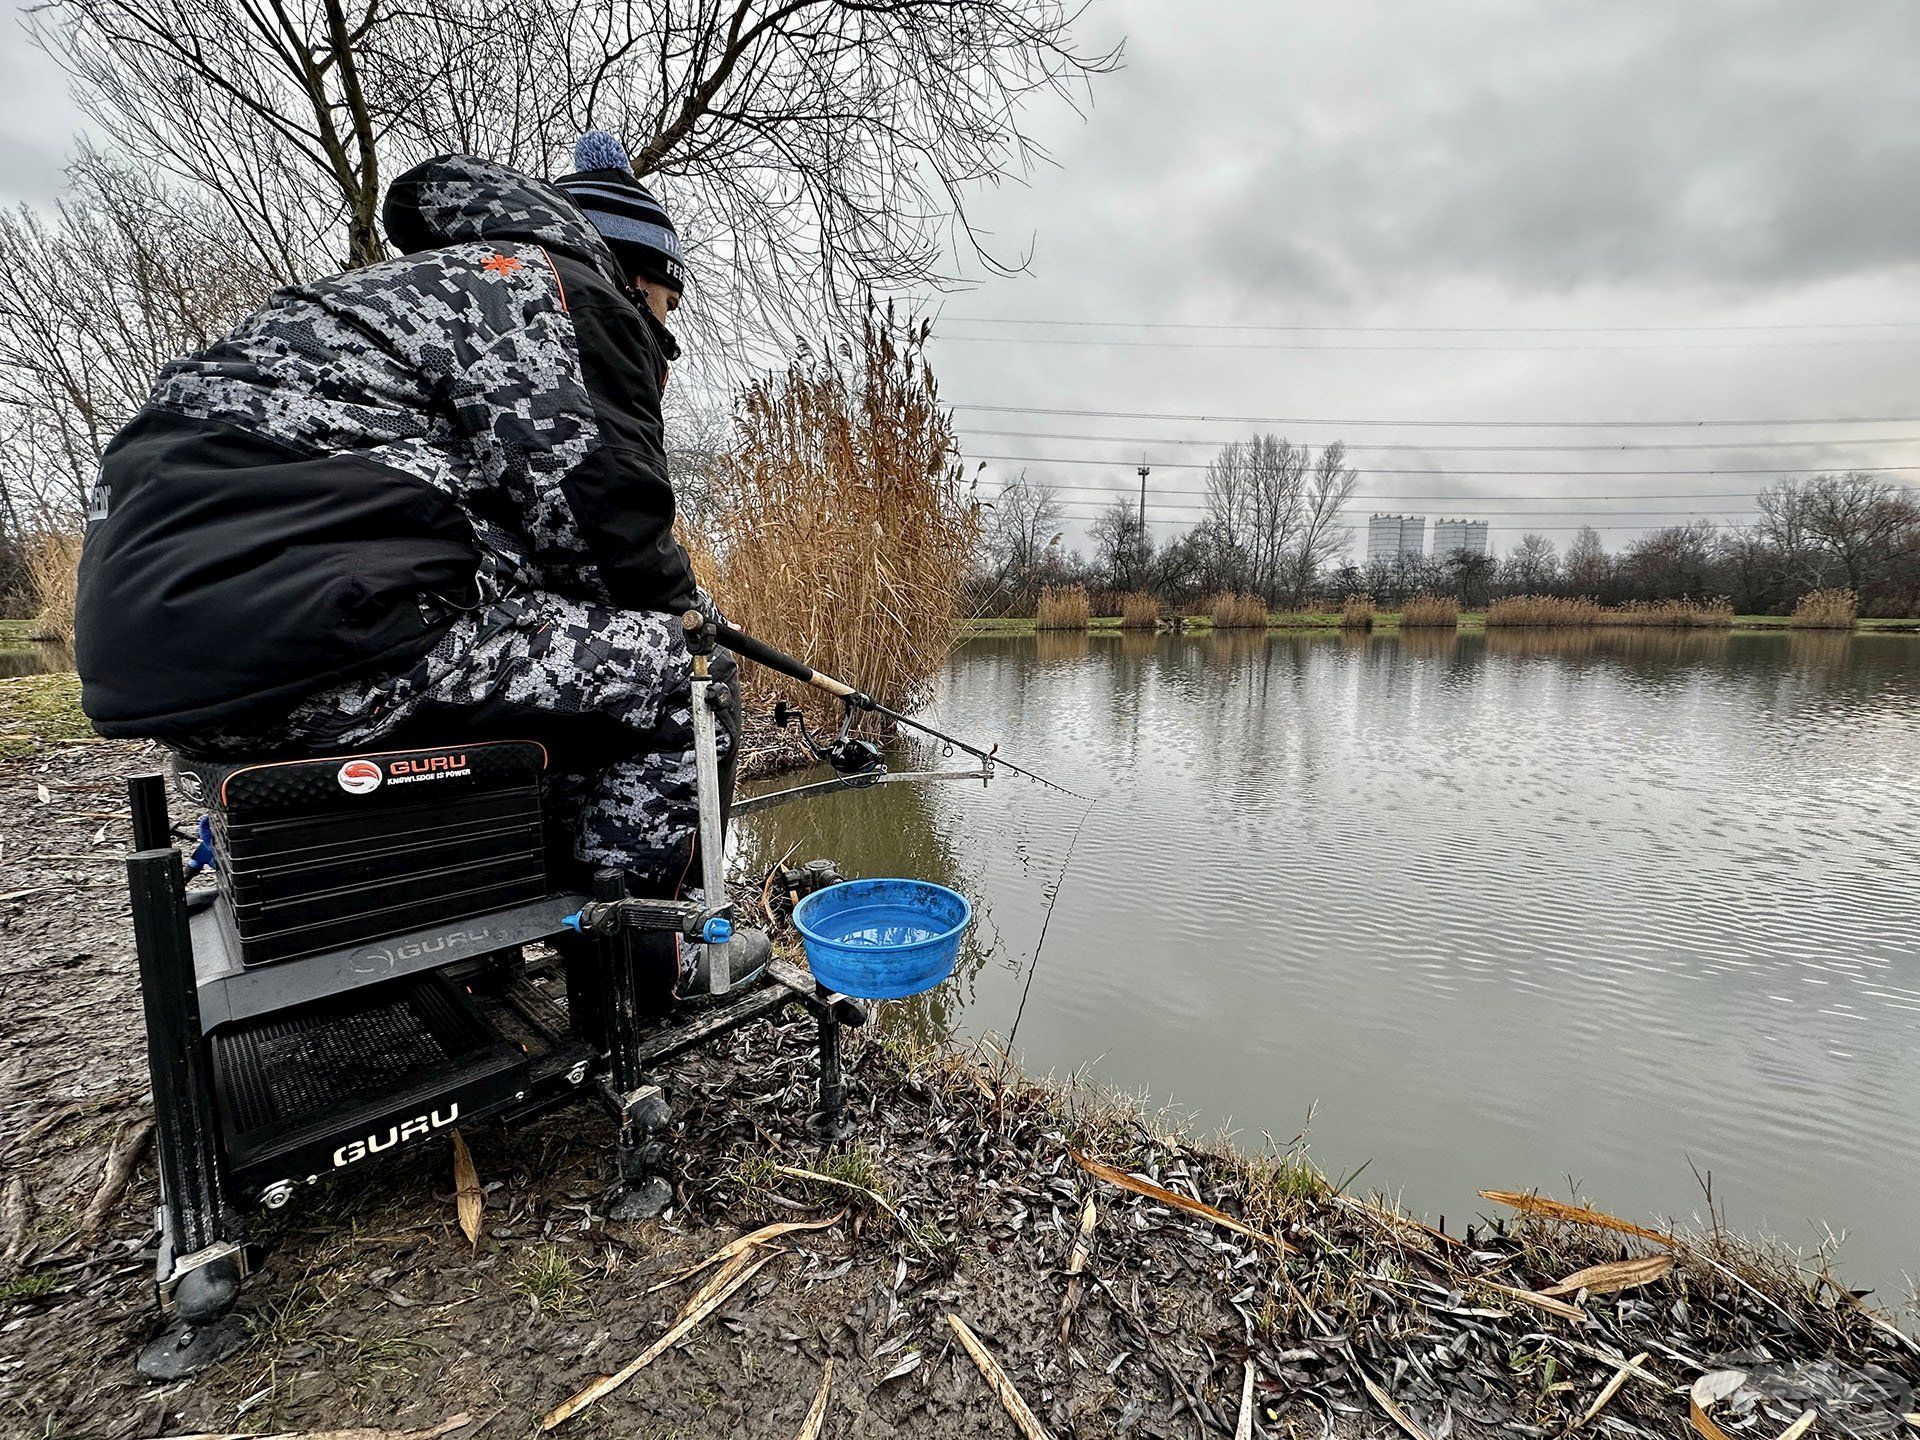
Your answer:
[33,0,1117,359]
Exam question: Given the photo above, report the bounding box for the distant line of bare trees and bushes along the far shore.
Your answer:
[972,453,1920,616]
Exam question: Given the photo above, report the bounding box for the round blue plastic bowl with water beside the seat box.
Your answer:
[793,879,973,1000]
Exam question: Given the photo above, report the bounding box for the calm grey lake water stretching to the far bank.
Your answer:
[743,632,1920,1302]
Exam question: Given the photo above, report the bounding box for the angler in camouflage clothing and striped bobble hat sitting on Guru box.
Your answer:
[75,131,764,1000]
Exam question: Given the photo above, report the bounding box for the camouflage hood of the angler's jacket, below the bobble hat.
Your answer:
[380,156,626,286]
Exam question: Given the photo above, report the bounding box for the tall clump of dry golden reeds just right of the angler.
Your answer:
[689,307,979,725]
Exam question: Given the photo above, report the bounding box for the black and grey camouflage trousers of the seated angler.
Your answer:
[196,591,737,893]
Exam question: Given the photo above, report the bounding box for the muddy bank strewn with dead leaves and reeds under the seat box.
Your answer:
[0,743,1920,1440]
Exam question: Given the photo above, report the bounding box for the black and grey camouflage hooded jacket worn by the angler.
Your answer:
[75,156,693,739]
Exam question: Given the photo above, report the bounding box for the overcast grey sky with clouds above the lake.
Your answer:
[0,0,1920,549]
